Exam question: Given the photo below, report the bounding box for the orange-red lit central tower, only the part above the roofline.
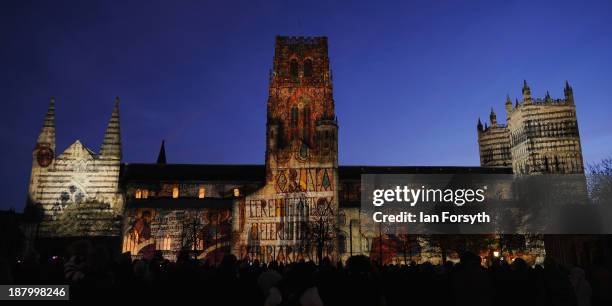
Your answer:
[266,37,338,181]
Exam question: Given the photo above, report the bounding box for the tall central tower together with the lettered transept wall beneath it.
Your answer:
[234,36,338,261]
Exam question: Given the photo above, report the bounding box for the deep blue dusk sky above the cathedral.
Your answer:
[0,0,612,210]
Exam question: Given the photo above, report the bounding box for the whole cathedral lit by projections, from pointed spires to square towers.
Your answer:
[26,36,584,263]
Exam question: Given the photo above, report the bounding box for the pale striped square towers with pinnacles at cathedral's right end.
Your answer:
[477,82,584,175]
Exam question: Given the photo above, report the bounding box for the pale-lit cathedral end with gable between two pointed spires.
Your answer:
[27,98,123,238]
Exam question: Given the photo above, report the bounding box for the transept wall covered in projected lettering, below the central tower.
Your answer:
[235,184,338,261]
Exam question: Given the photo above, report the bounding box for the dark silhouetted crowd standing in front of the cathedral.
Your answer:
[0,241,612,306]
